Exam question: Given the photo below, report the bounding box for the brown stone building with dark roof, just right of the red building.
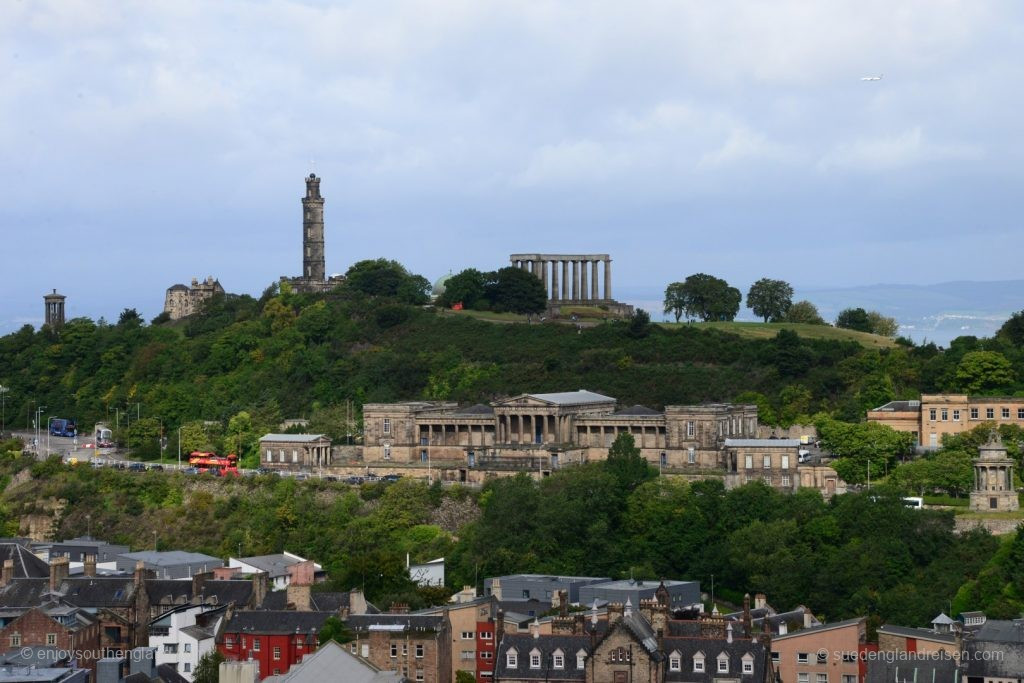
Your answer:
[346,612,454,683]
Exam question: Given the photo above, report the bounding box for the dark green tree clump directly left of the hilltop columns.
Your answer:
[437,266,548,313]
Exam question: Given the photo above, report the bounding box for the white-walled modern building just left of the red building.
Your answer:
[148,604,227,681]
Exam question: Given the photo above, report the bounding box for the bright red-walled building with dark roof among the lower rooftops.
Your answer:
[217,610,337,680]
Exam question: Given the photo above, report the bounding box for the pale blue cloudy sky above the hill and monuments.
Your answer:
[0,0,1024,333]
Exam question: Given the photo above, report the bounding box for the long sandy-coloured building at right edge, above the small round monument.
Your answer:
[867,393,1024,449]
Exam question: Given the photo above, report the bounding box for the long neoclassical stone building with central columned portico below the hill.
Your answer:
[362,389,758,474]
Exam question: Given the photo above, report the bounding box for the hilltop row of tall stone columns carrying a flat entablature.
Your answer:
[509,254,611,301]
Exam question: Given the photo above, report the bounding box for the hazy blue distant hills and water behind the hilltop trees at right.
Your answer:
[620,280,1024,346]
